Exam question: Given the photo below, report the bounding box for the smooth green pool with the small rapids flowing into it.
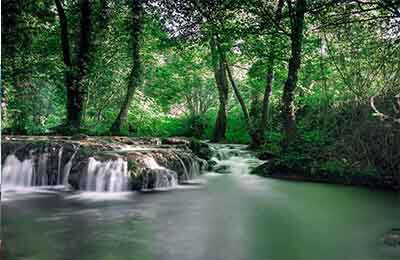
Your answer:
[2,146,400,260]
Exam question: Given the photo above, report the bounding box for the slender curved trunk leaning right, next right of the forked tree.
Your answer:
[110,0,142,134]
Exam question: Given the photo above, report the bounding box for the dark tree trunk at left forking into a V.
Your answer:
[55,0,91,132]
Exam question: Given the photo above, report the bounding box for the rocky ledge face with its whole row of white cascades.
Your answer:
[2,141,206,192]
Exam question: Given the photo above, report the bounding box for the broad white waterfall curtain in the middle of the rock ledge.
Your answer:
[84,157,129,192]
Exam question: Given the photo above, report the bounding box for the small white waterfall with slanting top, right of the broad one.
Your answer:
[142,156,178,190]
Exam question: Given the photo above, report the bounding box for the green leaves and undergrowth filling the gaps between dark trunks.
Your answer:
[1,0,400,183]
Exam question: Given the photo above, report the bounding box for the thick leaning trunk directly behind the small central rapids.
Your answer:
[211,37,229,142]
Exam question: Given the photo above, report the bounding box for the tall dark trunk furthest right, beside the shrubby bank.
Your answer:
[282,0,306,150]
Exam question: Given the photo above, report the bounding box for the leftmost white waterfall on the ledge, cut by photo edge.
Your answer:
[2,154,34,187]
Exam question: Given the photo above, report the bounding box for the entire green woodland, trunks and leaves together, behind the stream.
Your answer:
[1,0,400,185]
